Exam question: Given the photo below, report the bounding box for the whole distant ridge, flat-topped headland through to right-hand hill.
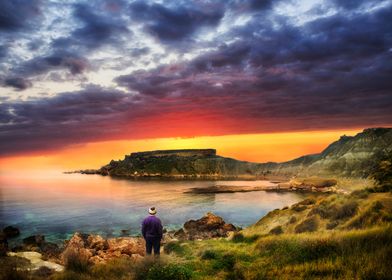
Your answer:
[89,128,392,178]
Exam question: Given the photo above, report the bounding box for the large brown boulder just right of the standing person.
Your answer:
[174,212,237,240]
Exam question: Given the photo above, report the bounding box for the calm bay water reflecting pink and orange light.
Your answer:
[0,173,303,242]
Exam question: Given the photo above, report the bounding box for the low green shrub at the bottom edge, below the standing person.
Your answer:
[146,263,192,280]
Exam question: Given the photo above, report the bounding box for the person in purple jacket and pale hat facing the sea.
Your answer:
[142,207,162,256]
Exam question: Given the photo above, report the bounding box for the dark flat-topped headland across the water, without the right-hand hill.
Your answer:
[98,149,259,178]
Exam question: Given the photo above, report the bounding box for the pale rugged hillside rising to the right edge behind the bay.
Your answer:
[271,128,392,177]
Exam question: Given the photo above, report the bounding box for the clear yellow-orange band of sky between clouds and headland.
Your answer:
[0,129,362,173]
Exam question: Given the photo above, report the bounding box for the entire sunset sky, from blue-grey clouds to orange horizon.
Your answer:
[0,0,392,170]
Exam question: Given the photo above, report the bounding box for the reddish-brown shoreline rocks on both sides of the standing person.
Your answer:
[0,213,239,272]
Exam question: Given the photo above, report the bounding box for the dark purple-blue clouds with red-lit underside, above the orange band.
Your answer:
[0,0,392,155]
